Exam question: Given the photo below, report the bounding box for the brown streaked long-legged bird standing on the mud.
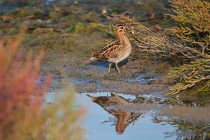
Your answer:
[90,25,131,73]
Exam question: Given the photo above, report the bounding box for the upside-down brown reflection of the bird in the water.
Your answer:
[87,94,143,134]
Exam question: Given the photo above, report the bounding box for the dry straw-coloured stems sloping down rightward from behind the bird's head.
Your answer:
[111,16,210,59]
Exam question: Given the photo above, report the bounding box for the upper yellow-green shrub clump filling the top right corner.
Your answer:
[170,0,210,53]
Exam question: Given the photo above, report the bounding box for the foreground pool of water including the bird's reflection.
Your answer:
[45,85,210,140]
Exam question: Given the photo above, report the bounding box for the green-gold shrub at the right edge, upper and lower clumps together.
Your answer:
[169,0,210,94]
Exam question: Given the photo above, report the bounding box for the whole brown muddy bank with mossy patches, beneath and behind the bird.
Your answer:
[0,0,176,95]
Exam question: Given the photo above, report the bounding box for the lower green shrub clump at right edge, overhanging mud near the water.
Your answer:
[168,59,210,95]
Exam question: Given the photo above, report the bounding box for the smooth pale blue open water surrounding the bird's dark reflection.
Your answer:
[75,93,179,140]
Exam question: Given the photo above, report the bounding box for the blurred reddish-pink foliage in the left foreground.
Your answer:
[0,39,50,135]
